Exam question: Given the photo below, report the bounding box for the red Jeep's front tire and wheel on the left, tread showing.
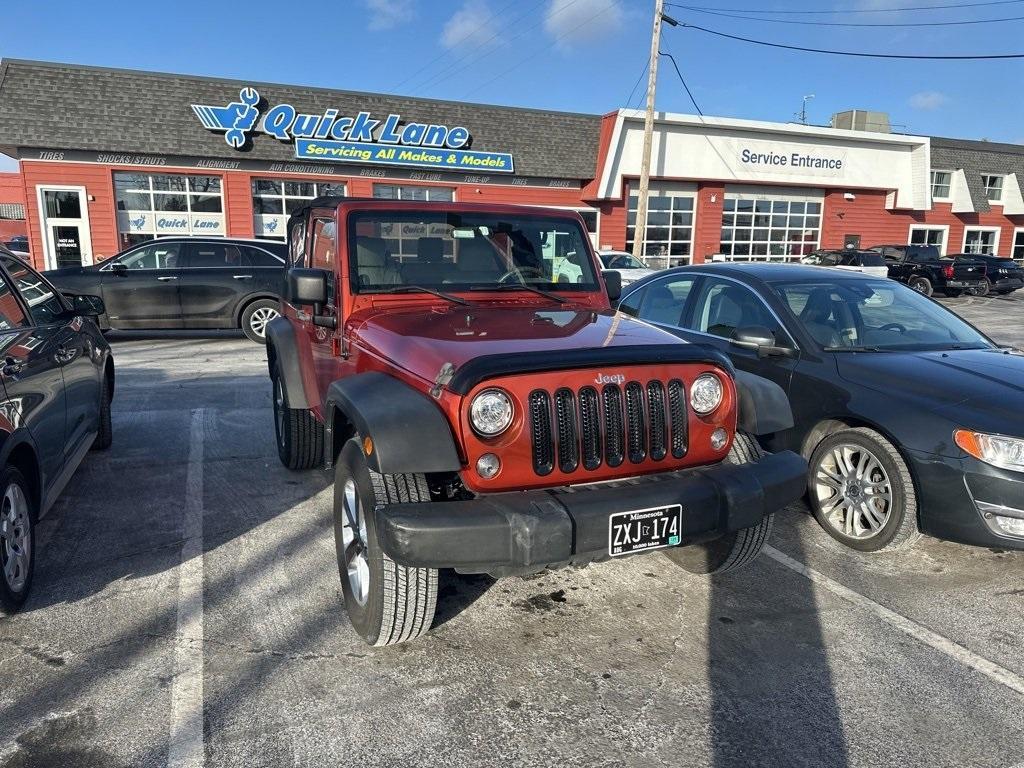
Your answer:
[334,437,437,646]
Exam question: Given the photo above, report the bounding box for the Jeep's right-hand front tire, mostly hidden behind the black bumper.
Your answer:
[665,432,774,575]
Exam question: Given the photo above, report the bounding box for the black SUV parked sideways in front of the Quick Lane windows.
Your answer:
[44,238,287,343]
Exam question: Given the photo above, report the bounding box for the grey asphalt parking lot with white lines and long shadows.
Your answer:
[0,296,1024,768]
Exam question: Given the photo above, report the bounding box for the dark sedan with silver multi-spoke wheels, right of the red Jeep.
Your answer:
[620,264,1024,552]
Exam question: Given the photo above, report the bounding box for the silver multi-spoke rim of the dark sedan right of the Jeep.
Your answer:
[814,442,893,540]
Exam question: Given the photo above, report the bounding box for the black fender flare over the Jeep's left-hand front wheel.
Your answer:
[324,371,462,474]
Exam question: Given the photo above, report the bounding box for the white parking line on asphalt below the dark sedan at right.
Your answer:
[764,546,1024,694]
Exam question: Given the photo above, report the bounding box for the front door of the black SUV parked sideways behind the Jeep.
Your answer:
[100,240,184,329]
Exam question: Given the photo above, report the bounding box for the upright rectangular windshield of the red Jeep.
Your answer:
[348,210,598,293]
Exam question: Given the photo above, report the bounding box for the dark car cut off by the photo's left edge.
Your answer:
[0,246,114,613]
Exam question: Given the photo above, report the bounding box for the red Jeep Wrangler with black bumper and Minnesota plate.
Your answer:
[267,198,806,645]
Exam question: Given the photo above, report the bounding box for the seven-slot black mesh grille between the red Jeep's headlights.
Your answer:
[528,379,688,475]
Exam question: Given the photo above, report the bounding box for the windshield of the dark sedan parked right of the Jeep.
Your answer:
[772,280,994,351]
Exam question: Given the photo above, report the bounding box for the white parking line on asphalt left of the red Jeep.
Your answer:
[167,409,204,768]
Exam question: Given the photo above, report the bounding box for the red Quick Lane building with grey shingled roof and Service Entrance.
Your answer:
[0,60,1024,268]
